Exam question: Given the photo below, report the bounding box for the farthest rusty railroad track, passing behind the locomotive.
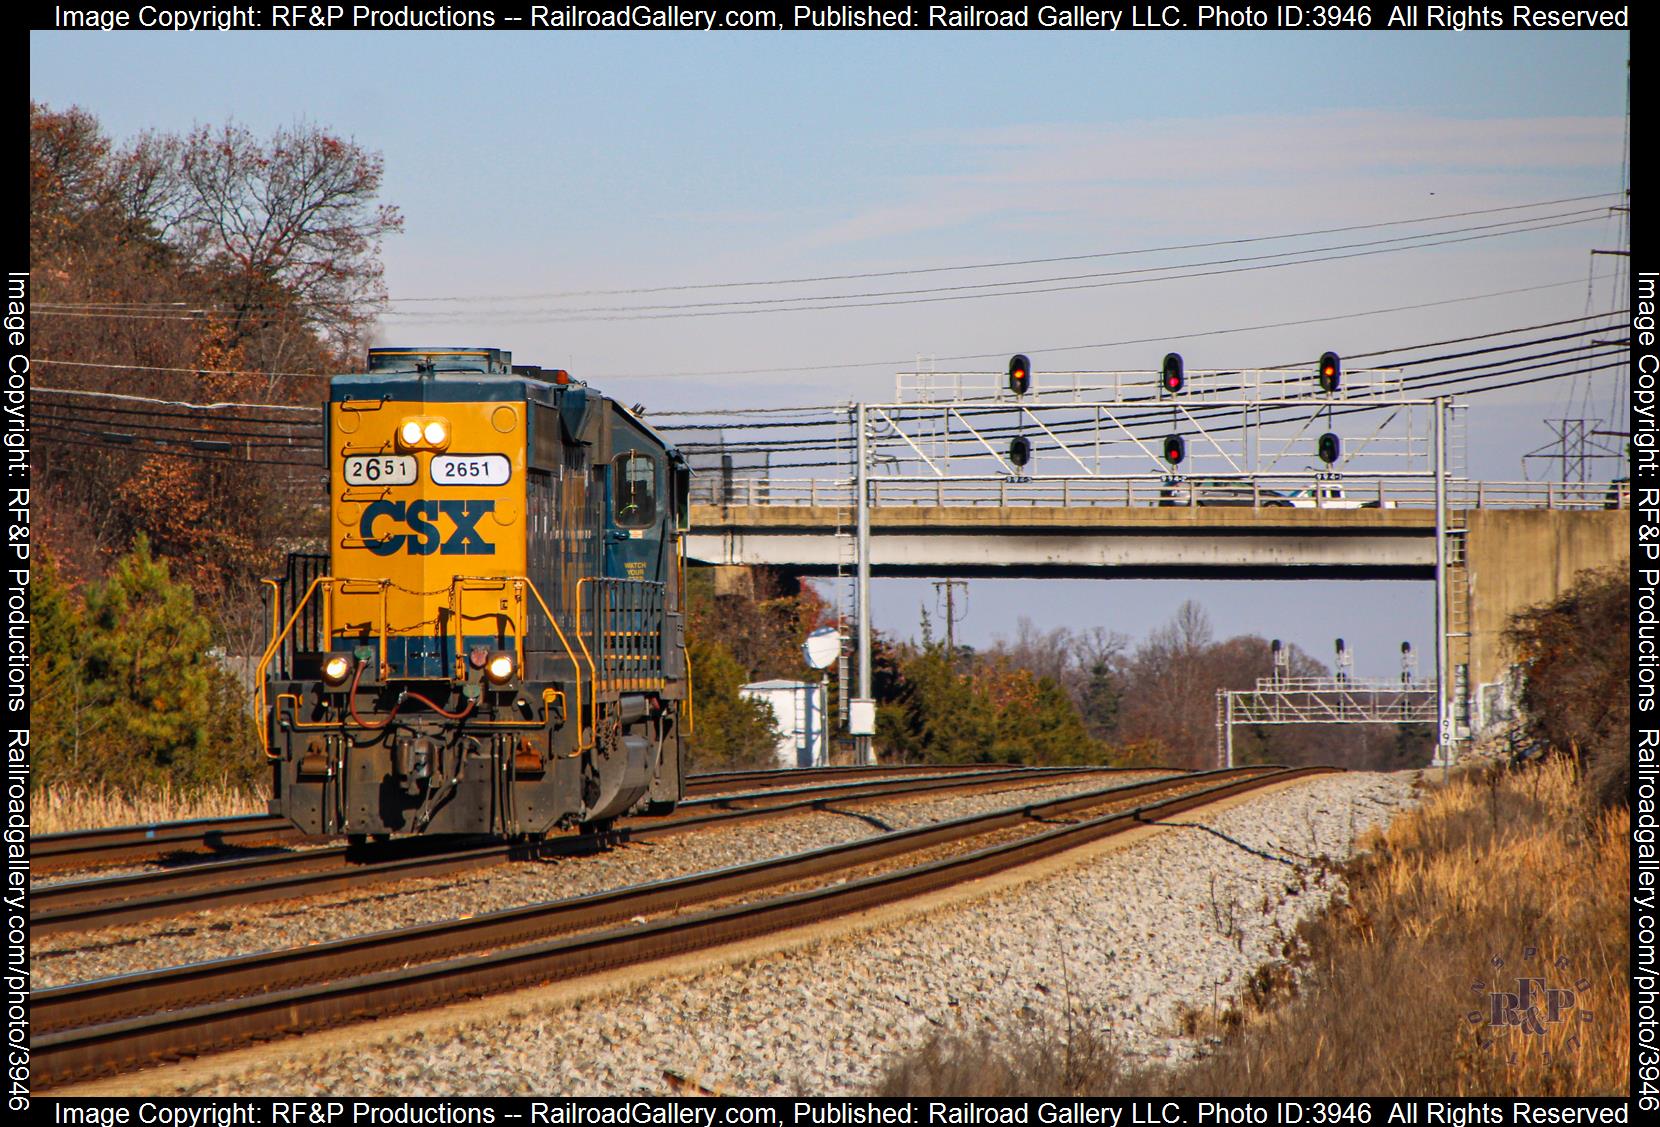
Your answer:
[28,764,1044,873]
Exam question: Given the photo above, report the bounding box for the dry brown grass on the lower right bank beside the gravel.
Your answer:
[883,760,1630,1097]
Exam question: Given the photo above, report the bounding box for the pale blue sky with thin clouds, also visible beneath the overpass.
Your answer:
[30,32,1630,672]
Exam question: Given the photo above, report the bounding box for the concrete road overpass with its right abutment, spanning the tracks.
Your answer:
[686,476,1632,750]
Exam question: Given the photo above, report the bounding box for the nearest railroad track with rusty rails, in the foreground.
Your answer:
[30,767,1331,1087]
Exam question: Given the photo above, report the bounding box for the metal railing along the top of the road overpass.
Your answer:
[692,475,1632,510]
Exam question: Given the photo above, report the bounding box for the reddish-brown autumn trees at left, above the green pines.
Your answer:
[30,103,402,596]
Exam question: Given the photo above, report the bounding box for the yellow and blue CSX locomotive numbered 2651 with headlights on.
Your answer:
[257,349,691,840]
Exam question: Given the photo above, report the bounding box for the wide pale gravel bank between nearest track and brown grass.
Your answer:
[156,772,1416,1095]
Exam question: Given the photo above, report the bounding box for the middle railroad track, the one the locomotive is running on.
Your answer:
[28,767,1148,939]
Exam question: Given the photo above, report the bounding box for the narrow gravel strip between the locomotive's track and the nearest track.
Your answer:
[30,770,1169,989]
